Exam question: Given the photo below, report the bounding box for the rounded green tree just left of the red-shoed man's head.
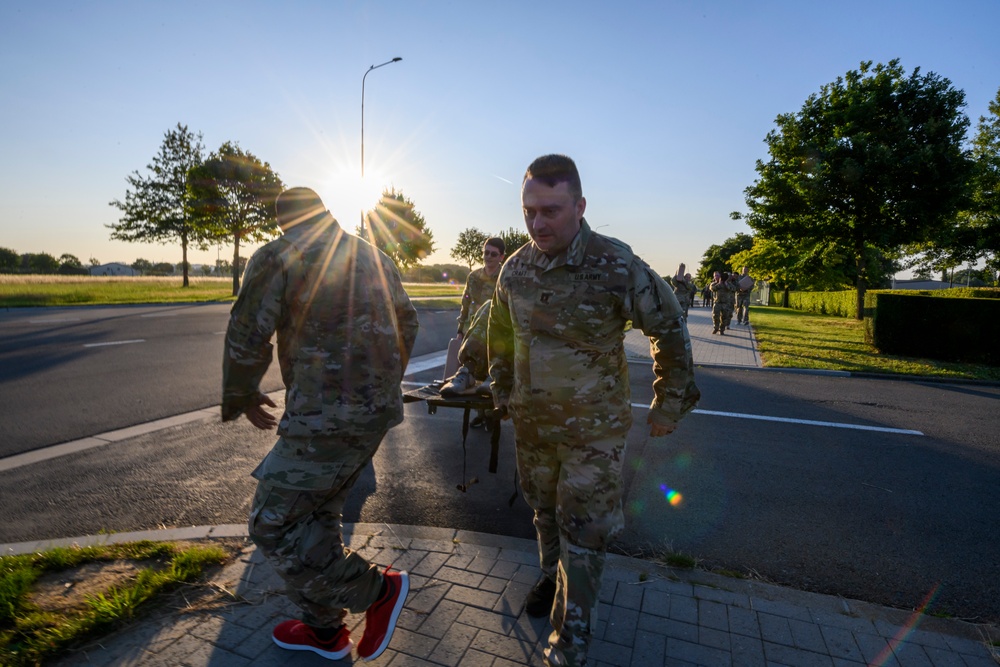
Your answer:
[188,141,284,296]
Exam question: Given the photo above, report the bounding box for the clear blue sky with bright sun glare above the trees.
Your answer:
[0,0,1000,274]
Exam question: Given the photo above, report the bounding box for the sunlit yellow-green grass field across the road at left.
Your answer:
[0,275,464,308]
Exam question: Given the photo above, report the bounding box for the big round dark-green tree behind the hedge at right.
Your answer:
[737,60,971,318]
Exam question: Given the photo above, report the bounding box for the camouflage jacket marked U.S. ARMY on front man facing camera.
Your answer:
[489,220,700,435]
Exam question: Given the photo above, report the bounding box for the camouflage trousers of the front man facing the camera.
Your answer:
[514,415,625,666]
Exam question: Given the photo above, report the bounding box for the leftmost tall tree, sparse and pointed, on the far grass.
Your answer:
[106,123,210,287]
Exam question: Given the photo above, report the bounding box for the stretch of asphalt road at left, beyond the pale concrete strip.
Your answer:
[0,304,455,457]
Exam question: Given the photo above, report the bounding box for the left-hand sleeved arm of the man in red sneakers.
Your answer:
[222,249,284,421]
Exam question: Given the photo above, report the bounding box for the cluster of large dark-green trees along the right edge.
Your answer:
[724,60,1000,316]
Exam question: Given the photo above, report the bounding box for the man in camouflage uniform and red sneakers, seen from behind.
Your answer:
[222,188,418,658]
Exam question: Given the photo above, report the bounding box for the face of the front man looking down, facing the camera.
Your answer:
[521,178,587,256]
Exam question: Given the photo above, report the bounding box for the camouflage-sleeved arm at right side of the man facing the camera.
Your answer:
[625,258,701,433]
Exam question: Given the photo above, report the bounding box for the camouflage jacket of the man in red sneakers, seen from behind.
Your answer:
[222,214,418,442]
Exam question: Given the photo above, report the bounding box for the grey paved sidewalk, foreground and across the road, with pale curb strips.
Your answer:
[0,308,1000,667]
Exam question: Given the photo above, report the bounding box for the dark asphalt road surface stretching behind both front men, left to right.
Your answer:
[0,306,1000,622]
